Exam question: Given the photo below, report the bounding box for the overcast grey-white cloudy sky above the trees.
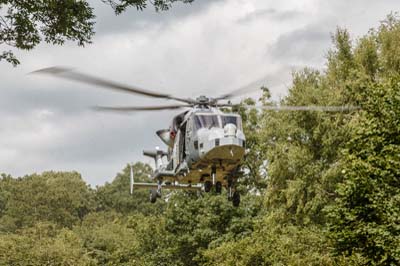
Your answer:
[0,0,400,186]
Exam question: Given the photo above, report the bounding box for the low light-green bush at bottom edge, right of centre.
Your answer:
[204,213,356,266]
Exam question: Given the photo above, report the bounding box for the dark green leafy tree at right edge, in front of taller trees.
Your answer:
[330,75,400,265]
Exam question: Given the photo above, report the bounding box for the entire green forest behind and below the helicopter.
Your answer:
[0,15,400,265]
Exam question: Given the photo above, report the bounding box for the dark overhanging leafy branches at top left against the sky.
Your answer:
[0,0,193,66]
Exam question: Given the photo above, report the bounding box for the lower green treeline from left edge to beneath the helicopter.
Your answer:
[0,163,260,265]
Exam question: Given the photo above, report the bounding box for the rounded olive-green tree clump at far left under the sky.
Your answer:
[0,172,94,231]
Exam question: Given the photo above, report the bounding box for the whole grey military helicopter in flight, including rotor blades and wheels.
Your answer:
[32,67,357,206]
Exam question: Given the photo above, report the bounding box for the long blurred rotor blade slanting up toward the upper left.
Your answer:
[31,67,194,103]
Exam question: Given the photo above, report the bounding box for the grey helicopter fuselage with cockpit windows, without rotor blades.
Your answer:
[144,106,246,186]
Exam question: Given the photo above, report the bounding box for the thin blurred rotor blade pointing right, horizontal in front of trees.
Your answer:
[218,104,361,112]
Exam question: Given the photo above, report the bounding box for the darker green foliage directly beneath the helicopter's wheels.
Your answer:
[161,193,260,265]
